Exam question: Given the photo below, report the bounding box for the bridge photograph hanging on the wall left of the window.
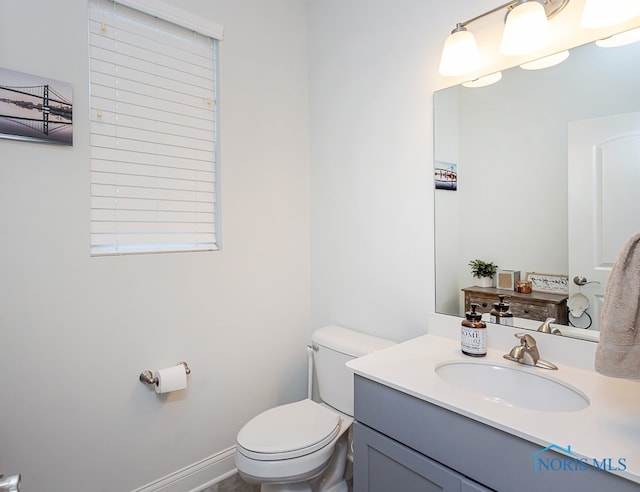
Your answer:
[0,68,73,145]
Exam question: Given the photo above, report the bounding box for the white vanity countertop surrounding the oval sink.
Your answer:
[347,334,640,483]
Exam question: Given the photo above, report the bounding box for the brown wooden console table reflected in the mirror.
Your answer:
[462,287,569,325]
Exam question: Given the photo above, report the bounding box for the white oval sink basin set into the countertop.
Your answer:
[435,361,589,412]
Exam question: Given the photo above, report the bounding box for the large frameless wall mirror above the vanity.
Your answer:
[434,36,640,340]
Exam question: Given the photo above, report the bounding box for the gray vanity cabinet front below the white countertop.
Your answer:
[353,375,640,492]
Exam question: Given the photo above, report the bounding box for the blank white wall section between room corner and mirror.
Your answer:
[310,0,495,340]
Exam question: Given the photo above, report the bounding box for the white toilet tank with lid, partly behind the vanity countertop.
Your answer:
[311,325,395,416]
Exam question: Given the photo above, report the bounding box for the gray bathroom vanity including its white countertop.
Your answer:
[348,320,640,492]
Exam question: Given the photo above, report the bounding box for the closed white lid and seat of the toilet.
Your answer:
[237,399,342,461]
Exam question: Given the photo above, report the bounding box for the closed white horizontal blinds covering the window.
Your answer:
[89,0,217,255]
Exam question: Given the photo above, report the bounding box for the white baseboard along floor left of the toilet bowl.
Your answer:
[132,446,236,492]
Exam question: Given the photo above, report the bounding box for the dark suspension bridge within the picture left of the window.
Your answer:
[0,84,73,136]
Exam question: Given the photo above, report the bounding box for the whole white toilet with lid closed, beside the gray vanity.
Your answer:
[235,325,394,492]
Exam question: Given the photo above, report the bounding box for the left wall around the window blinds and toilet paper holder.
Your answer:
[0,0,310,492]
